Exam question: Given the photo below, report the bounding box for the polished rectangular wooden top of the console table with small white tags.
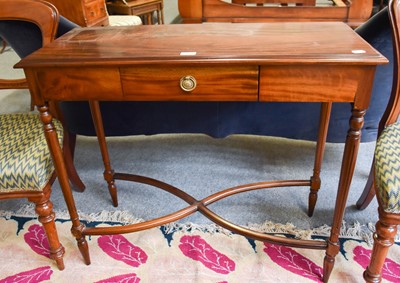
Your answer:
[16,22,387,68]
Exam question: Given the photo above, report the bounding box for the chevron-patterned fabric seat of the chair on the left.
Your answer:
[0,113,63,193]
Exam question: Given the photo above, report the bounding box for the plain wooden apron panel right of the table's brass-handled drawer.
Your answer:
[260,65,370,102]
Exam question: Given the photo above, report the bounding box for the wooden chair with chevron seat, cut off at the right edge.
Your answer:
[364,0,400,282]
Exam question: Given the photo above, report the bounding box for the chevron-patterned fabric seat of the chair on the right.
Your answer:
[375,123,400,213]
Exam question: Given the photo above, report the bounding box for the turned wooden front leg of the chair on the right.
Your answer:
[364,220,397,283]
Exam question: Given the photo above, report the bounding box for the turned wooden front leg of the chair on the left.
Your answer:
[31,189,64,270]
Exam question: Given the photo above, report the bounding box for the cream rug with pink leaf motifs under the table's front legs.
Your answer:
[0,216,400,283]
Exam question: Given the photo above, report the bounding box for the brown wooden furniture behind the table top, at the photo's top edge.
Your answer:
[178,0,373,27]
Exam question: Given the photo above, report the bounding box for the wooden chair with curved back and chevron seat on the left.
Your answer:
[0,0,79,270]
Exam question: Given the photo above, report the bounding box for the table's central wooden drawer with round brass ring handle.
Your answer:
[120,65,258,101]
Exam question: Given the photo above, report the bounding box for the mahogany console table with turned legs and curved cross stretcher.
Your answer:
[16,22,387,281]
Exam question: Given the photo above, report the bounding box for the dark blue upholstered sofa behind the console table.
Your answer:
[0,9,393,142]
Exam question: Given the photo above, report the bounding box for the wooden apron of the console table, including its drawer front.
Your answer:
[31,64,375,105]
